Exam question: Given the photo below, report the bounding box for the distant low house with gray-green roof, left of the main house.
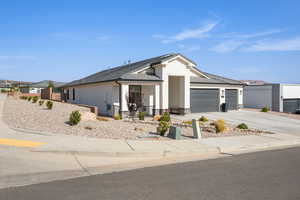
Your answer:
[20,80,65,94]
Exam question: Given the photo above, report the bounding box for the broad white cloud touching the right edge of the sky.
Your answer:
[244,37,300,51]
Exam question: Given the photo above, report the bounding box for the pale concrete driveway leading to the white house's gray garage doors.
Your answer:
[173,110,300,136]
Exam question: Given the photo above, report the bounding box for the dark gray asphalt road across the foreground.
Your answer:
[0,148,300,200]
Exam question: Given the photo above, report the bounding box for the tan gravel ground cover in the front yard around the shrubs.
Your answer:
[3,98,270,140]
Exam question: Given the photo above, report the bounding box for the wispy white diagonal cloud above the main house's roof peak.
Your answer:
[152,21,218,44]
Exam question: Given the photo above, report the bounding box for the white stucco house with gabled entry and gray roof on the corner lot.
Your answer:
[63,54,243,116]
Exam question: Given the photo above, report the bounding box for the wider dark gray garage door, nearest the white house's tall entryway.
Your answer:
[190,89,219,113]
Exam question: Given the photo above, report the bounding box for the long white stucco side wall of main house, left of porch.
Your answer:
[67,83,119,115]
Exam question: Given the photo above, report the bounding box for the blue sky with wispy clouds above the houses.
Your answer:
[0,0,300,83]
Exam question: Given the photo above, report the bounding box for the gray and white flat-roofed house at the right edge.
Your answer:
[244,84,300,113]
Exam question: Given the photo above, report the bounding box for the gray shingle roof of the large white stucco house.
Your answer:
[63,53,242,87]
